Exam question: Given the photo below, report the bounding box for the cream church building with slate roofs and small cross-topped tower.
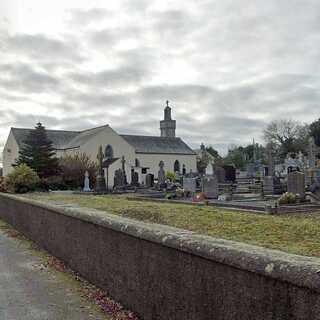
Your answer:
[3,101,197,188]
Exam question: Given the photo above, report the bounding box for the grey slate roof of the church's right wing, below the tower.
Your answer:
[120,135,195,155]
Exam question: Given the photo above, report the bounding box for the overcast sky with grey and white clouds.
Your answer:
[0,0,320,160]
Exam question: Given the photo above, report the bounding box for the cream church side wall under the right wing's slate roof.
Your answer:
[137,153,197,178]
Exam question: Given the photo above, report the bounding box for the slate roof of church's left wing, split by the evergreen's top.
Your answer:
[11,128,80,149]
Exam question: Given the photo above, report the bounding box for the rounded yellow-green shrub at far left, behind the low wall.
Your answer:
[5,163,40,193]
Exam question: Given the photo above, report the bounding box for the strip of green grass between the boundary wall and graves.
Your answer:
[26,193,320,257]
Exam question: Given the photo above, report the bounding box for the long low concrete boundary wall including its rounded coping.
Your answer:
[0,194,320,320]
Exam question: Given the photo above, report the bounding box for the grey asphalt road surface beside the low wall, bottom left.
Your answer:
[0,230,107,320]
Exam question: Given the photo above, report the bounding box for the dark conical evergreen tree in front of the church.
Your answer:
[16,122,59,178]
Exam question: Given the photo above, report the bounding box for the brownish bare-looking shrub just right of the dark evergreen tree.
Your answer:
[59,153,97,189]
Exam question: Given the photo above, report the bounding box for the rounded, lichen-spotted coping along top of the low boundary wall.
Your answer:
[0,193,320,292]
